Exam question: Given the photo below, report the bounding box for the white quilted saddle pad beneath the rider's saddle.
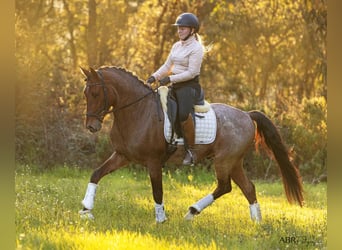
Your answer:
[164,108,217,145]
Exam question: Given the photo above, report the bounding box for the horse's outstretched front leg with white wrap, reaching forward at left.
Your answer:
[79,152,128,219]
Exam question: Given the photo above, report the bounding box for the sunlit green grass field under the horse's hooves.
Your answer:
[15,166,327,250]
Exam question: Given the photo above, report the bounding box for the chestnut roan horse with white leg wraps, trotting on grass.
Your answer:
[80,67,303,223]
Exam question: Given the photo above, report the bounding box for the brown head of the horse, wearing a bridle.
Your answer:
[81,68,111,133]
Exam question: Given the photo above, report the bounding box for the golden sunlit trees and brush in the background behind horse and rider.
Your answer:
[15,0,327,178]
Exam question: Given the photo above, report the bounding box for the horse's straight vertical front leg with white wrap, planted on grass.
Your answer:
[148,163,167,223]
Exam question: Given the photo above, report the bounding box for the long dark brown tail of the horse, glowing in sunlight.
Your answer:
[248,111,304,206]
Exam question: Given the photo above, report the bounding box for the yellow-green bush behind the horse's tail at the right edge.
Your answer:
[245,97,327,181]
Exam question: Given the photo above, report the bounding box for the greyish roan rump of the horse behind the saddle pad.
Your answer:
[211,103,254,154]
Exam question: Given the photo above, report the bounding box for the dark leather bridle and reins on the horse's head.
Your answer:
[86,71,154,122]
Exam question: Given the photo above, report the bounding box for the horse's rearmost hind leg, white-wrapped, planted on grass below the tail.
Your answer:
[231,161,261,222]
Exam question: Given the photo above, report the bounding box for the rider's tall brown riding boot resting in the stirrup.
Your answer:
[181,114,197,165]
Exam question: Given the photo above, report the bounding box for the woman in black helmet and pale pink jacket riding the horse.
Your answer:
[146,13,205,165]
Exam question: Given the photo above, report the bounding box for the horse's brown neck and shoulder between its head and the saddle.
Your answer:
[104,68,164,153]
